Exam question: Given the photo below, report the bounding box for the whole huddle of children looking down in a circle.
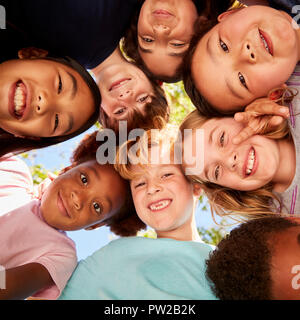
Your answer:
[0,0,300,299]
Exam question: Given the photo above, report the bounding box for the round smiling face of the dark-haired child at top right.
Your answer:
[191,6,300,111]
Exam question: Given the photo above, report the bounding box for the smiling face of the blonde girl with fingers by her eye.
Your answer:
[184,118,280,191]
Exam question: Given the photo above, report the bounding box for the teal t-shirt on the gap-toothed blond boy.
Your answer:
[59,237,216,300]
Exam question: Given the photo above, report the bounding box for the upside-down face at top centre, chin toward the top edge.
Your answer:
[138,0,198,77]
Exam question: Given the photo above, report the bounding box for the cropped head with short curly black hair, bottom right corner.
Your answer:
[206,217,300,300]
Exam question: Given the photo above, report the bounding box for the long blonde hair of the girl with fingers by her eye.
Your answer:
[179,89,295,220]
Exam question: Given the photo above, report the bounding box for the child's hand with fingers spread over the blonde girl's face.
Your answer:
[232,98,289,144]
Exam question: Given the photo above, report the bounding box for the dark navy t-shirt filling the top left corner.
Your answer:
[0,0,138,68]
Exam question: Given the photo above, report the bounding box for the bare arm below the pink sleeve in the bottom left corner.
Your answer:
[0,263,53,300]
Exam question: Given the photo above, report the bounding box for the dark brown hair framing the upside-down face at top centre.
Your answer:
[123,0,235,83]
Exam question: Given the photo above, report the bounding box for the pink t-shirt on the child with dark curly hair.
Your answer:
[0,159,77,299]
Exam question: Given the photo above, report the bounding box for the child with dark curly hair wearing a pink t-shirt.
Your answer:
[0,132,144,299]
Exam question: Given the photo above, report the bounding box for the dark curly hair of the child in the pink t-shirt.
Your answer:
[62,131,146,237]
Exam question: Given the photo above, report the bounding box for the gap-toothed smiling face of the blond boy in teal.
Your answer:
[130,165,194,232]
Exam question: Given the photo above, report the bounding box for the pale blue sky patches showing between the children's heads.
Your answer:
[25,127,230,259]
